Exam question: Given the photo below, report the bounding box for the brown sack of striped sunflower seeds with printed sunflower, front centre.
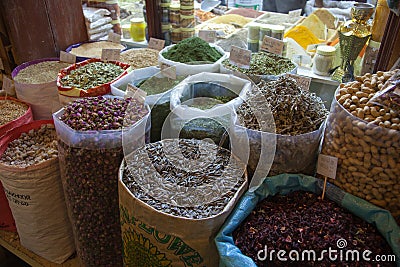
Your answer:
[118,139,247,267]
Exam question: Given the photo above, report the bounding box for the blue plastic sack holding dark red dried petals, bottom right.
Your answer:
[215,174,400,267]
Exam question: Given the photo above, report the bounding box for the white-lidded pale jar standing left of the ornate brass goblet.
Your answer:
[312,45,336,76]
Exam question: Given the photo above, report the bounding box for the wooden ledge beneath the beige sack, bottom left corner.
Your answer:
[0,230,80,267]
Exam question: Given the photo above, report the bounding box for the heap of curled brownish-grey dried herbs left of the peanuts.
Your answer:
[238,77,329,135]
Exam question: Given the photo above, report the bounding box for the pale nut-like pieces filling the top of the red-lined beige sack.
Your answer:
[0,124,58,167]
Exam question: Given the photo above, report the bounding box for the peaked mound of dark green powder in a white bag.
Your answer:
[162,37,222,63]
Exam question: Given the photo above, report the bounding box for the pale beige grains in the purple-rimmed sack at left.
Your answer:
[13,61,71,84]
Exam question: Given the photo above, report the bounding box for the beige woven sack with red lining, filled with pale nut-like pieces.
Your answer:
[0,120,75,264]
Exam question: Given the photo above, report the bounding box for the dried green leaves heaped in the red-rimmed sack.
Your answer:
[61,62,124,90]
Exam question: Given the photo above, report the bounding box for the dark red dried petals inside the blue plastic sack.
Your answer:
[233,191,396,266]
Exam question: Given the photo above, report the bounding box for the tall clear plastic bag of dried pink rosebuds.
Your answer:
[53,96,150,266]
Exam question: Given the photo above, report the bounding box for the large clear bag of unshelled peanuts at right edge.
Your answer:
[322,71,400,219]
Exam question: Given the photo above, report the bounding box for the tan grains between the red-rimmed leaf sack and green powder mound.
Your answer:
[119,48,158,69]
